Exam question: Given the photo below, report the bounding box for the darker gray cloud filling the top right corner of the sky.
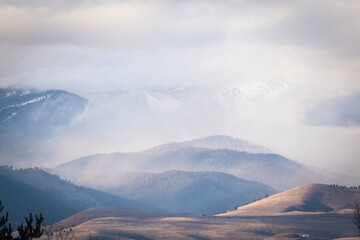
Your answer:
[244,1,360,57]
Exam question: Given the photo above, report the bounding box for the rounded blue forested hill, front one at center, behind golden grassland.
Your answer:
[102,171,276,214]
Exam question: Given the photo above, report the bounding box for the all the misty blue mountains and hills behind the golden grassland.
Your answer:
[0,88,358,225]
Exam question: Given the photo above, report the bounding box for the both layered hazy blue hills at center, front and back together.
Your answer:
[51,135,346,214]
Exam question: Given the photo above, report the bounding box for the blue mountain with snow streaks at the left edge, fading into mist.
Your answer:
[0,89,88,166]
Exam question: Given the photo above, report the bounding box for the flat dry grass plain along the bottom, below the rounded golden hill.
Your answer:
[43,209,357,240]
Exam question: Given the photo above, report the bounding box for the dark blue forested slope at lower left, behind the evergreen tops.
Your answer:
[0,167,150,224]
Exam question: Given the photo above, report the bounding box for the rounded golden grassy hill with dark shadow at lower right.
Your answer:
[219,184,360,216]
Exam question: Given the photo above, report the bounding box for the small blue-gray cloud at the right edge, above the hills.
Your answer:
[306,92,360,127]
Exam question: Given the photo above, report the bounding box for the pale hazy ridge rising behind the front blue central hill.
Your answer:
[54,136,332,190]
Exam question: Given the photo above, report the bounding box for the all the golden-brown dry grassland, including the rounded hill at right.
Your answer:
[43,184,359,240]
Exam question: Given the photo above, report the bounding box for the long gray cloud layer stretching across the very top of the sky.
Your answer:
[0,0,360,57]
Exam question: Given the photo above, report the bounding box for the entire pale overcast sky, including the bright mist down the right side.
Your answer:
[0,0,360,174]
